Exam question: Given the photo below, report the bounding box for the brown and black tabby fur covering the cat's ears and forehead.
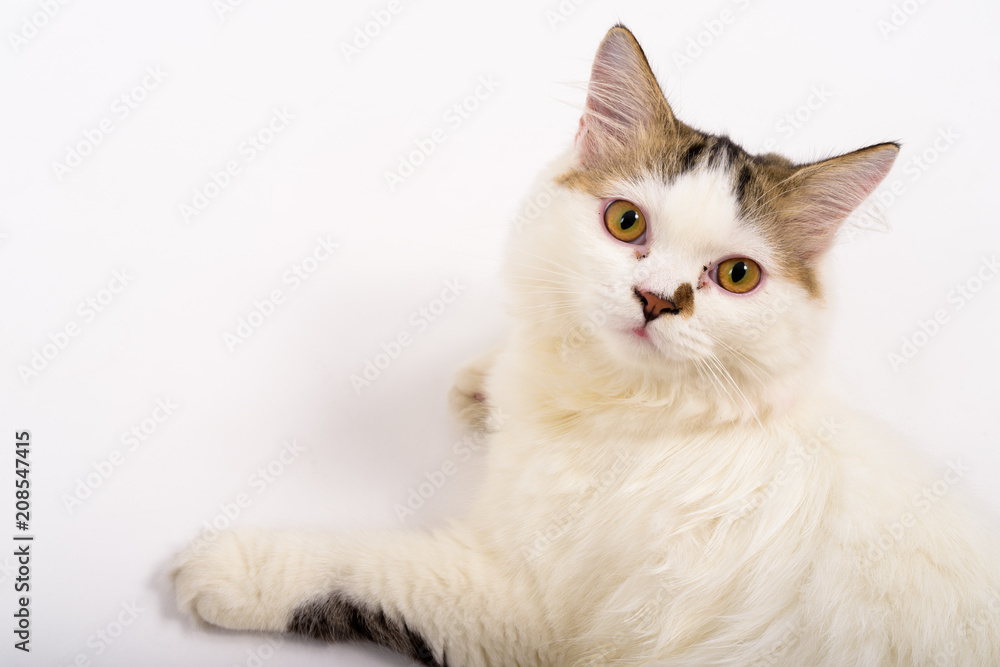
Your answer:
[557,26,899,297]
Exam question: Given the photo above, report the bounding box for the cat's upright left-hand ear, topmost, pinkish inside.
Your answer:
[576,25,676,168]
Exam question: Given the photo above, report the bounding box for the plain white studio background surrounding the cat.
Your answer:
[0,0,1000,667]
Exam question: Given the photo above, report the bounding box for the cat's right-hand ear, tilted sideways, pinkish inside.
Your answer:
[772,143,899,264]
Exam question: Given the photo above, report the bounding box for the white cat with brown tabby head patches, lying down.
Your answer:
[172,25,1000,666]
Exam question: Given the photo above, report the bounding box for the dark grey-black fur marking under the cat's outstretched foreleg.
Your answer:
[288,593,448,667]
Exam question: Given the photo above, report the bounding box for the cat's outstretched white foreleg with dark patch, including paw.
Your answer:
[172,529,549,665]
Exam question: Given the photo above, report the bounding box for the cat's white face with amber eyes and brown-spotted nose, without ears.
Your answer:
[549,169,810,370]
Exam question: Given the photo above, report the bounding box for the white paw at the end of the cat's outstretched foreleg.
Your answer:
[170,529,288,631]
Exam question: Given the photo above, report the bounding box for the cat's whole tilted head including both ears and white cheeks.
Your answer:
[507,26,899,422]
